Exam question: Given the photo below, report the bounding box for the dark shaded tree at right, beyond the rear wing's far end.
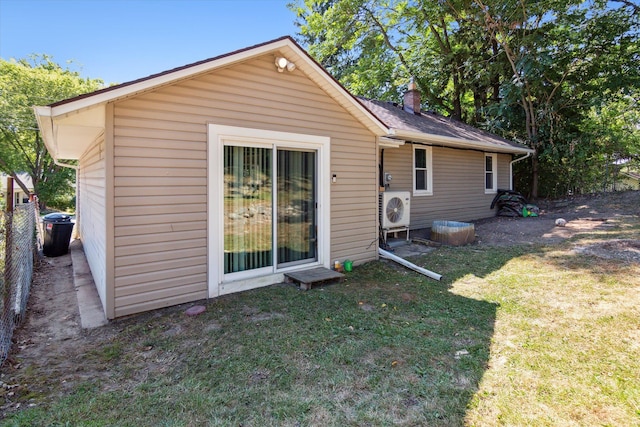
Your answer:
[473,0,640,198]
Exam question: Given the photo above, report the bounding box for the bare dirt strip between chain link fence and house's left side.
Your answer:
[0,254,117,419]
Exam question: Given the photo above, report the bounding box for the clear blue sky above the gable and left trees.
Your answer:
[0,0,296,84]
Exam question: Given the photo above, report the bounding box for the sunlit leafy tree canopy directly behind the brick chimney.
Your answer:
[290,0,494,119]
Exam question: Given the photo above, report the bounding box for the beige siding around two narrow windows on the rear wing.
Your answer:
[384,143,511,230]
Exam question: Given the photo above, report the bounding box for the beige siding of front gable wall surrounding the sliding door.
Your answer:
[114,55,377,317]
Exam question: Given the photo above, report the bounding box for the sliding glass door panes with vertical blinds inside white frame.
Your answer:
[223,145,317,275]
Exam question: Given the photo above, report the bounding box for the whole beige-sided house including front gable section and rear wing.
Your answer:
[35,37,529,319]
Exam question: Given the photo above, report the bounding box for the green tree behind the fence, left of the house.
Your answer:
[0,55,103,211]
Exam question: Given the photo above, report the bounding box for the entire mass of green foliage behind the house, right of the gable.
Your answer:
[290,0,640,197]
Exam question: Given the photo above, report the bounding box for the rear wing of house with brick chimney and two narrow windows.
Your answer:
[359,84,533,229]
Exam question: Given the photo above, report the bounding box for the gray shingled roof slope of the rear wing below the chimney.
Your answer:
[357,97,526,151]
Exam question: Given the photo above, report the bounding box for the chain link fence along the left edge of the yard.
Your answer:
[0,202,39,365]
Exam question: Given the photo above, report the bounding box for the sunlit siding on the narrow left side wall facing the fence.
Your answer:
[77,137,107,307]
